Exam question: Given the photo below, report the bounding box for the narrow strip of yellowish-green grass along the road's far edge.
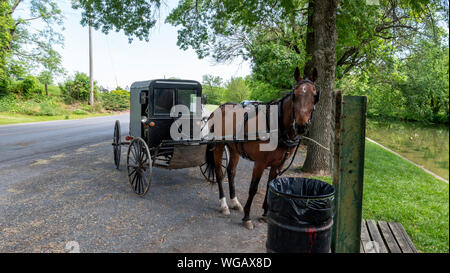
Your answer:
[0,112,118,125]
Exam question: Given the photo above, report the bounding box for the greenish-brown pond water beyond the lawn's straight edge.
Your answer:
[366,119,449,180]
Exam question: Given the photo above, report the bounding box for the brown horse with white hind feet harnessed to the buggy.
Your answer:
[206,68,320,229]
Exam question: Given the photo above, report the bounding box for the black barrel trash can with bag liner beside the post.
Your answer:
[266,177,334,253]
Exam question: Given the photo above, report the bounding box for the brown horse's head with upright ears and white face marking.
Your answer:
[292,67,320,135]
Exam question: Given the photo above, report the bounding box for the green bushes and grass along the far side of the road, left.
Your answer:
[0,73,130,124]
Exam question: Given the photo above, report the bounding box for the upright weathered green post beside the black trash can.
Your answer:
[331,92,367,253]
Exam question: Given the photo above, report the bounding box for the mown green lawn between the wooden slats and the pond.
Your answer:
[312,142,449,253]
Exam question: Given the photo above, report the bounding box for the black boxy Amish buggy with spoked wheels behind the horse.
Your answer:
[112,79,229,196]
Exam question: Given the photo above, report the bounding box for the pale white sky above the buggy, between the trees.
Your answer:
[58,0,251,88]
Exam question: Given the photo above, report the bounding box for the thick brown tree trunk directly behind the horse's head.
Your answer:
[303,0,338,175]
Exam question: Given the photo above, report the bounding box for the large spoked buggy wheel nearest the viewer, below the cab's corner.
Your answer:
[127,137,152,196]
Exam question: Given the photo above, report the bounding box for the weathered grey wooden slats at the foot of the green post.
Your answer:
[361,220,417,253]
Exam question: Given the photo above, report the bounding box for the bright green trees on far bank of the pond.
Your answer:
[338,40,449,123]
